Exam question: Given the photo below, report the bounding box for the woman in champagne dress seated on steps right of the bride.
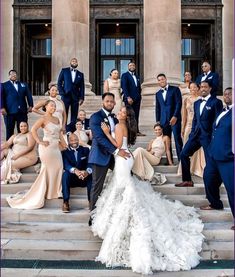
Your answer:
[132,123,173,185]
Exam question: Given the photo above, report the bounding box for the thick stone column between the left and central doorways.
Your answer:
[52,0,93,95]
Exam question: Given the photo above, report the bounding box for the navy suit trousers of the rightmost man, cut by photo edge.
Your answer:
[203,157,234,216]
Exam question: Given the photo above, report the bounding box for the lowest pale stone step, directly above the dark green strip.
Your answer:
[2,239,234,260]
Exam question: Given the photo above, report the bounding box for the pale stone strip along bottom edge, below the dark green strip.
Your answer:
[1,268,234,277]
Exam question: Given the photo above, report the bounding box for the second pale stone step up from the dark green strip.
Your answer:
[1,222,234,241]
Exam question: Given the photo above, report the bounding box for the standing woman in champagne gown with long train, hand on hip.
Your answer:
[7,100,65,209]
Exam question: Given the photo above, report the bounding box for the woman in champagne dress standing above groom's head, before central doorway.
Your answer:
[104,69,123,114]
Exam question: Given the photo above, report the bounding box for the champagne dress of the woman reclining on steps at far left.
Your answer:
[1,133,38,183]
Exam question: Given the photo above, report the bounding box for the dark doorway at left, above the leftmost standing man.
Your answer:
[22,22,51,95]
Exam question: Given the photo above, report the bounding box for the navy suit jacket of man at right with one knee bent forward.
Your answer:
[189,97,223,141]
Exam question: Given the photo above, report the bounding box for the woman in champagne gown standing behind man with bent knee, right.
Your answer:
[178,83,206,177]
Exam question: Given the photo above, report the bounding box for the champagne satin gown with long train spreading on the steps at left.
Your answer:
[7,122,63,209]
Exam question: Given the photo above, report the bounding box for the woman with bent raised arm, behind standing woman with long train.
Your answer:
[33,85,66,133]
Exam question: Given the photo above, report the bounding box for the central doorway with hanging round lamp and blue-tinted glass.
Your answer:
[96,21,138,94]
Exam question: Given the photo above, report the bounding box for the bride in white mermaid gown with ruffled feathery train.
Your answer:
[92,107,204,274]
